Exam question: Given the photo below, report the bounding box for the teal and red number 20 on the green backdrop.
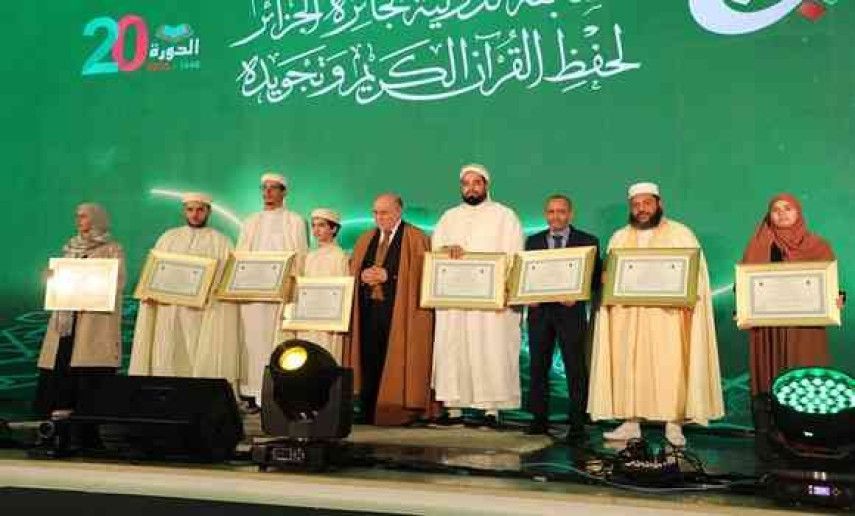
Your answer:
[80,14,148,75]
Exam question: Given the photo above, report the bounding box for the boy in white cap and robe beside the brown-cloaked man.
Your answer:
[297,208,350,364]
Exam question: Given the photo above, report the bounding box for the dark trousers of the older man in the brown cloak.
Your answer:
[359,299,392,423]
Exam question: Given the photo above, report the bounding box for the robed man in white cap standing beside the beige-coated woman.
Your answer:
[128,193,238,387]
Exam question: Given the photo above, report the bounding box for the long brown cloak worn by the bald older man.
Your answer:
[343,223,434,425]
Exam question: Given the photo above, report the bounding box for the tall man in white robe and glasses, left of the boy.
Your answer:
[237,173,309,405]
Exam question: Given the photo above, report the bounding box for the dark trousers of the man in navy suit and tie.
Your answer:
[528,303,588,426]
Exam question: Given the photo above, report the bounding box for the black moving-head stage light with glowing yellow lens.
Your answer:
[252,339,353,470]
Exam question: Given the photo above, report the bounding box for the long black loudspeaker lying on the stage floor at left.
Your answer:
[69,376,243,461]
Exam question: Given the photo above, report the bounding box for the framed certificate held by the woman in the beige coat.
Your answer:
[45,258,119,312]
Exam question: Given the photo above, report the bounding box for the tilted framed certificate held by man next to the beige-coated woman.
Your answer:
[134,251,217,308]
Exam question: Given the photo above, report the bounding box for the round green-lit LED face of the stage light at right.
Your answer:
[772,367,855,414]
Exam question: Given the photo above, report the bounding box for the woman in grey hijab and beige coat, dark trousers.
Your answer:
[34,203,125,416]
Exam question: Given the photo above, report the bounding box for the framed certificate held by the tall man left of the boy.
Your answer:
[216,251,294,303]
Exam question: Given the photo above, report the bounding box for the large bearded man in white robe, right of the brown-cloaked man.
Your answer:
[431,164,523,428]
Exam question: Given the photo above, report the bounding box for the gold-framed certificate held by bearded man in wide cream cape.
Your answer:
[603,248,700,307]
